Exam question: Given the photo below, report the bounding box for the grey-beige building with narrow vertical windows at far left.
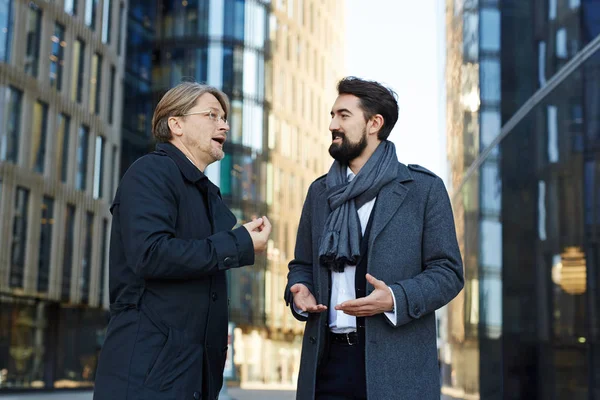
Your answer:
[0,0,126,393]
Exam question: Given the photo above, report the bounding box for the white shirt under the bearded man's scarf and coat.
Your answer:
[294,168,397,333]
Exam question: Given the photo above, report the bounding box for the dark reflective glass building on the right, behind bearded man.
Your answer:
[440,0,600,399]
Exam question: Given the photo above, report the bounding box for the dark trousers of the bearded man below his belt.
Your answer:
[315,334,367,400]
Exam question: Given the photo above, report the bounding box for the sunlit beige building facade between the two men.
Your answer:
[234,0,345,387]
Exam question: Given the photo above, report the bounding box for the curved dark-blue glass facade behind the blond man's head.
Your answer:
[120,0,282,386]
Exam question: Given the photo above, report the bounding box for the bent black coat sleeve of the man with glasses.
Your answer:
[118,157,254,279]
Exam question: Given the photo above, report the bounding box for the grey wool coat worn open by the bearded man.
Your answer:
[284,163,464,400]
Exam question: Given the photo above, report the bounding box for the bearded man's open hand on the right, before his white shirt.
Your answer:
[335,274,394,317]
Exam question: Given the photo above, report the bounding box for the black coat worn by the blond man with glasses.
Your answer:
[94,143,254,400]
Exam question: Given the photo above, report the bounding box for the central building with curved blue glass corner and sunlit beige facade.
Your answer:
[121,0,344,387]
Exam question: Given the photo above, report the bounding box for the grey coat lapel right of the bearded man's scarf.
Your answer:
[369,162,413,248]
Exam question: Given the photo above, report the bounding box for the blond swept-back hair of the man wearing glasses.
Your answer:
[152,82,229,142]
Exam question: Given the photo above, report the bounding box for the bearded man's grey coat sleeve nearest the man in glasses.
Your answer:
[284,184,314,321]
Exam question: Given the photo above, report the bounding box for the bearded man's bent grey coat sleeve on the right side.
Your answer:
[386,177,464,327]
